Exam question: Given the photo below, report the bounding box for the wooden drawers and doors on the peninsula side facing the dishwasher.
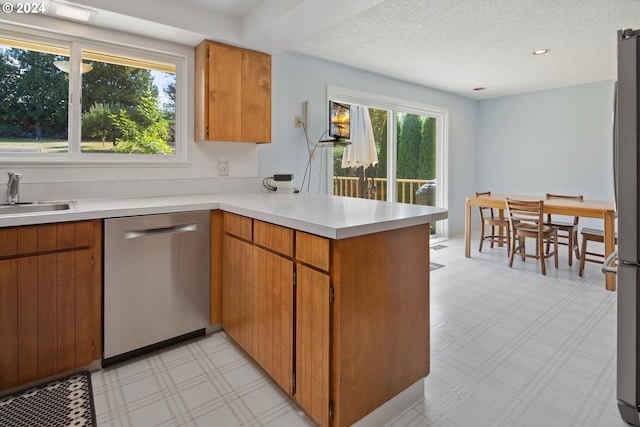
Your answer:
[222,213,330,425]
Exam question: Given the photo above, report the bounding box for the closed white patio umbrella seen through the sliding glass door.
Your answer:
[342,104,378,169]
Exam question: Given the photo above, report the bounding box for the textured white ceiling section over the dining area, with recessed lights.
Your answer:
[292,0,640,99]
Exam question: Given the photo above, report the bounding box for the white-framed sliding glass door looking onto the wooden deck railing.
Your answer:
[327,87,448,239]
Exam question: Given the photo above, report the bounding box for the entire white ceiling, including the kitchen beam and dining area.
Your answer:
[5,0,640,99]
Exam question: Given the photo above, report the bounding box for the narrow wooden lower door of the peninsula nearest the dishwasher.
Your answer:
[222,234,254,353]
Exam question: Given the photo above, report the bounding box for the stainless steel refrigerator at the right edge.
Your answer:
[614,30,640,426]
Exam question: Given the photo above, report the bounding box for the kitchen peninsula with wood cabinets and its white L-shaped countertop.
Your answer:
[0,193,447,426]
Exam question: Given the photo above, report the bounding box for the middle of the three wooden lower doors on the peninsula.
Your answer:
[252,246,293,395]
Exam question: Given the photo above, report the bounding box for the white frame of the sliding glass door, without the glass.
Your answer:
[325,85,449,237]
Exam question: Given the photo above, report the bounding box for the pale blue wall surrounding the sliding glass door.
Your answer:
[258,53,477,235]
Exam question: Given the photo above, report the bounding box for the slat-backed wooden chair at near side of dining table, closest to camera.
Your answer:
[507,198,558,275]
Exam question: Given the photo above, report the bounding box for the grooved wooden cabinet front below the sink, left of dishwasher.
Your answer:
[0,249,100,389]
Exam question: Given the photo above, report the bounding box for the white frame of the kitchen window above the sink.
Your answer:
[0,23,189,167]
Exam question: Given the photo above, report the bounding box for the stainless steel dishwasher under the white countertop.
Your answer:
[103,211,210,366]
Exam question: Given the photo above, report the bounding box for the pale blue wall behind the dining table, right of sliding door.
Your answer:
[478,81,614,200]
